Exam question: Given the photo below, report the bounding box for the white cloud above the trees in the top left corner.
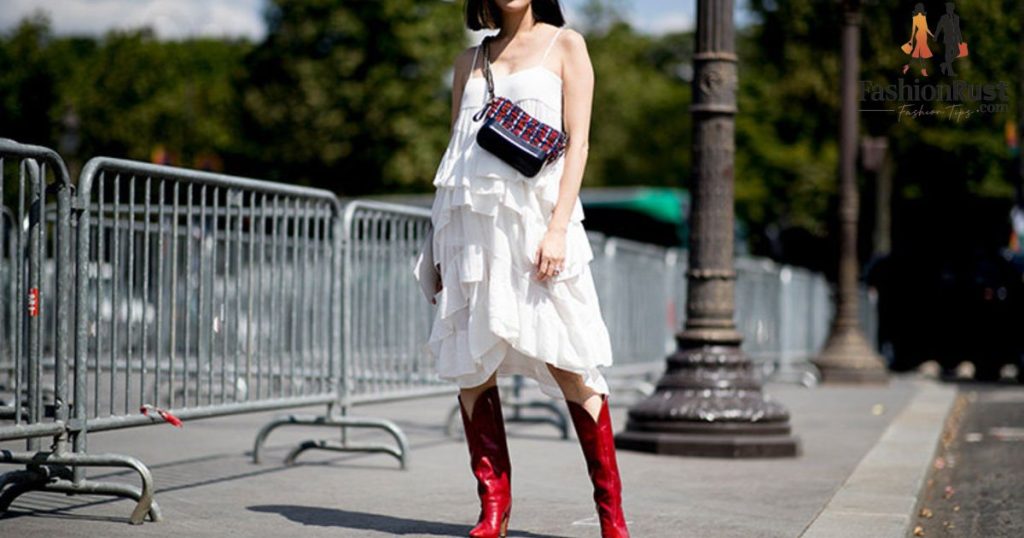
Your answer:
[0,0,266,40]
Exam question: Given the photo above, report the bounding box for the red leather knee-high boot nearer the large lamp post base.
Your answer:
[566,395,630,538]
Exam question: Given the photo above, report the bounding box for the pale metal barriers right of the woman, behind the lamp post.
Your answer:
[590,228,878,387]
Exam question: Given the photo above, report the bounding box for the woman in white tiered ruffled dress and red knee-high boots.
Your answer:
[416,0,629,538]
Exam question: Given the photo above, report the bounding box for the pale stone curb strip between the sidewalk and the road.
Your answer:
[801,380,956,538]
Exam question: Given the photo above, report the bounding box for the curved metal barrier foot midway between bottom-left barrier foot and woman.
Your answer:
[253,415,409,469]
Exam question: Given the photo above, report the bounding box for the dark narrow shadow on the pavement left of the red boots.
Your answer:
[248,504,558,538]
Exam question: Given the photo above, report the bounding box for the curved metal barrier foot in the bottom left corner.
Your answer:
[0,450,163,525]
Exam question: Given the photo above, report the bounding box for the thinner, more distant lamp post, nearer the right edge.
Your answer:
[814,0,889,383]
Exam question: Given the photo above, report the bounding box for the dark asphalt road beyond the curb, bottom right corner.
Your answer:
[913,382,1024,538]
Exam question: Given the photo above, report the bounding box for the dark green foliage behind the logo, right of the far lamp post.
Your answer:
[861,0,1024,200]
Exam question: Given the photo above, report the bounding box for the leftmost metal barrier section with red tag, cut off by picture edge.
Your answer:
[0,139,72,448]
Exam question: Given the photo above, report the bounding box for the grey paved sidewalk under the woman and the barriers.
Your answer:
[0,374,951,538]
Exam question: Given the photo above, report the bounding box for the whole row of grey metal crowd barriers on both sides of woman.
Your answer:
[0,139,877,524]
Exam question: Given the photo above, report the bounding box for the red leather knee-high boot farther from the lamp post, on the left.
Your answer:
[459,386,512,538]
